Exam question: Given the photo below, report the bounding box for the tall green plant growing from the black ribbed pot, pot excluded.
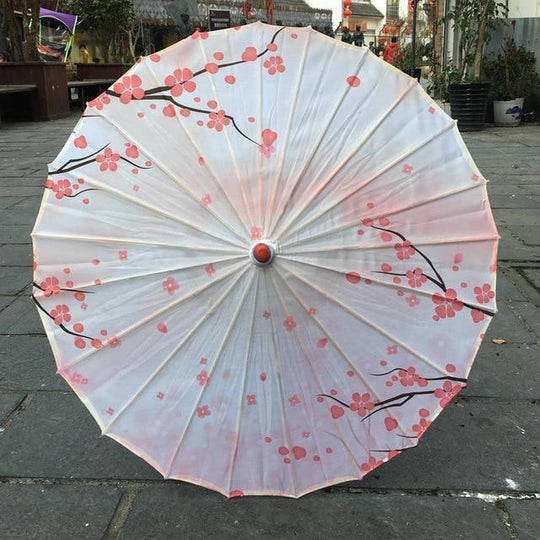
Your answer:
[443,0,508,82]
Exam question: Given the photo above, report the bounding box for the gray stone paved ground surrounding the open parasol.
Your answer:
[0,117,540,540]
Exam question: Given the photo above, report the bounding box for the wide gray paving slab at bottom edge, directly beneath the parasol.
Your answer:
[120,485,507,540]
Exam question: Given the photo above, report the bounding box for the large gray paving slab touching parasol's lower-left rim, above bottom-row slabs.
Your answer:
[0,392,162,480]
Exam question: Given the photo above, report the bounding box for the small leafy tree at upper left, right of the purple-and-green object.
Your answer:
[63,0,134,62]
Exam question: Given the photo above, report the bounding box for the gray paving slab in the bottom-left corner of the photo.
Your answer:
[0,484,120,540]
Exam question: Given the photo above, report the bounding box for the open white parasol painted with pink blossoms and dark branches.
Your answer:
[32,23,498,497]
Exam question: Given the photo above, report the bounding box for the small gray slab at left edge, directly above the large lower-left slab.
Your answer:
[0,336,70,391]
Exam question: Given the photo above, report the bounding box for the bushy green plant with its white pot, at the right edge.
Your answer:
[484,37,540,127]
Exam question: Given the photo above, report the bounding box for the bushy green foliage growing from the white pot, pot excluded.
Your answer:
[484,37,540,101]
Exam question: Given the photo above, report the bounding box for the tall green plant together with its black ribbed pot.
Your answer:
[443,0,507,131]
